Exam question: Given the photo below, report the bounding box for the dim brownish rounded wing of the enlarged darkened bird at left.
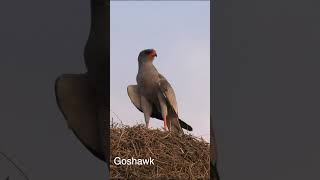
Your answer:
[55,74,105,160]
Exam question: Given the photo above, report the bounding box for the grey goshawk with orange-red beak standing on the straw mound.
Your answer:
[127,49,192,133]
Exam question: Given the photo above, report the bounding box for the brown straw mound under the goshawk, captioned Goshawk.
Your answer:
[110,124,210,179]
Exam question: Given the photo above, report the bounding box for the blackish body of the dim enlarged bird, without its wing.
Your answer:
[84,0,110,169]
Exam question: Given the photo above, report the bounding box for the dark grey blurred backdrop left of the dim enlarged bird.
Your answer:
[0,0,107,180]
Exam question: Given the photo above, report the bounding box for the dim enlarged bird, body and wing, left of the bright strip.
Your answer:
[55,0,110,163]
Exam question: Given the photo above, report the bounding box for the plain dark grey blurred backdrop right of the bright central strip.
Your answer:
[215,0,320,180]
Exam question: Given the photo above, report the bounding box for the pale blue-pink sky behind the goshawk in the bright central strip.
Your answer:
[110,1,210,141]
